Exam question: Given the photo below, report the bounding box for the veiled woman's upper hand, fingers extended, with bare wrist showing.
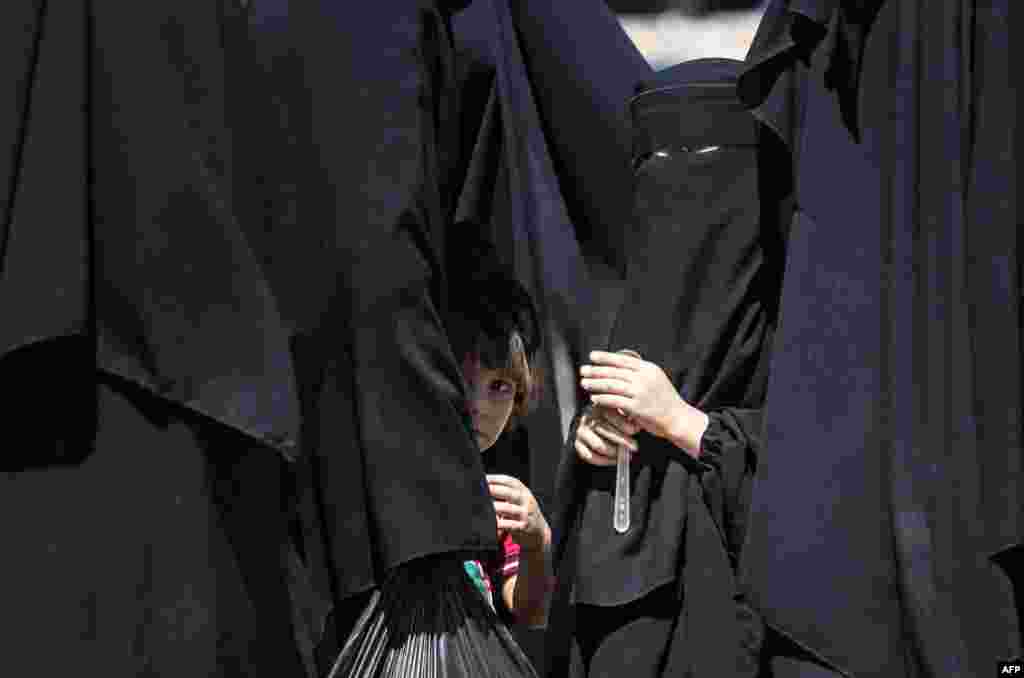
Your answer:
[580,351,708,458]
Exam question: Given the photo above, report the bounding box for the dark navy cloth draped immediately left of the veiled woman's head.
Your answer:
[509,0,653,274]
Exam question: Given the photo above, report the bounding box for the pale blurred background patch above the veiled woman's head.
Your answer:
[608,0,767,69]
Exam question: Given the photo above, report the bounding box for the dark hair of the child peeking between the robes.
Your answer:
[450,241,541,430]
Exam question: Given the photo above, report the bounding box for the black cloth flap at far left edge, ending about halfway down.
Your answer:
[0,2,91,366]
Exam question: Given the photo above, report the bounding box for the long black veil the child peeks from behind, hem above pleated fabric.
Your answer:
[266,2,497,610]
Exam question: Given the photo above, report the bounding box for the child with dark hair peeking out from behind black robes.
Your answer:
[452,240,554,627]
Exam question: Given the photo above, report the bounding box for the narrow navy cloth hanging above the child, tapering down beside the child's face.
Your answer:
[453,1,594,524]
